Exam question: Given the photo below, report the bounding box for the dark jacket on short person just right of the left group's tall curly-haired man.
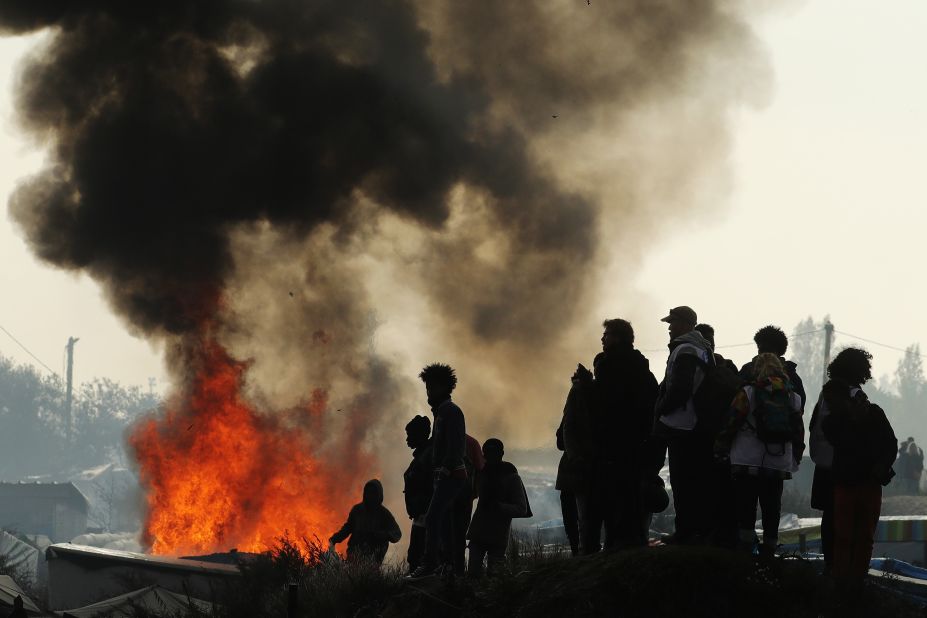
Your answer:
[467,461,532,547]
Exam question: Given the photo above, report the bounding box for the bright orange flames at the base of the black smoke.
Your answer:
[129,342,372,555]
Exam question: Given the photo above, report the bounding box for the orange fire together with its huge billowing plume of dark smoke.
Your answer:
[0,0,764,553]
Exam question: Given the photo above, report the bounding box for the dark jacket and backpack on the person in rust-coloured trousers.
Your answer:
[821,390,898,485]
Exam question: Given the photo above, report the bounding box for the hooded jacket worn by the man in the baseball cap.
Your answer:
[655,330,714,431]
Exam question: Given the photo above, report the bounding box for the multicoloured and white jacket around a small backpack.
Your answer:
[715,378,805,478]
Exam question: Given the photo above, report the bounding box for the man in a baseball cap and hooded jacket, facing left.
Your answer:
[654,306,714,544]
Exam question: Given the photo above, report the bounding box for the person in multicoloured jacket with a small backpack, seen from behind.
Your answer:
[715,354,805,557]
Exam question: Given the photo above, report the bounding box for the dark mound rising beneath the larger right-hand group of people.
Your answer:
[378,547,927,618]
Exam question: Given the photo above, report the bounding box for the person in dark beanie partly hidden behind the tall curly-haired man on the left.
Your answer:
[403,416,434,573]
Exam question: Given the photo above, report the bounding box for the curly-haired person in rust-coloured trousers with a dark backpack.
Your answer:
[815,348,898,594]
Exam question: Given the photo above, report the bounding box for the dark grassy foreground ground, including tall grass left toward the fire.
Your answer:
[183,538,927,618]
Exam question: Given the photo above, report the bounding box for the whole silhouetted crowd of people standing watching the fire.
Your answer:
[331,306,908,587]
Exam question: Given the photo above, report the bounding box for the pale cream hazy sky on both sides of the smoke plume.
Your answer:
[0,0,927,386]
